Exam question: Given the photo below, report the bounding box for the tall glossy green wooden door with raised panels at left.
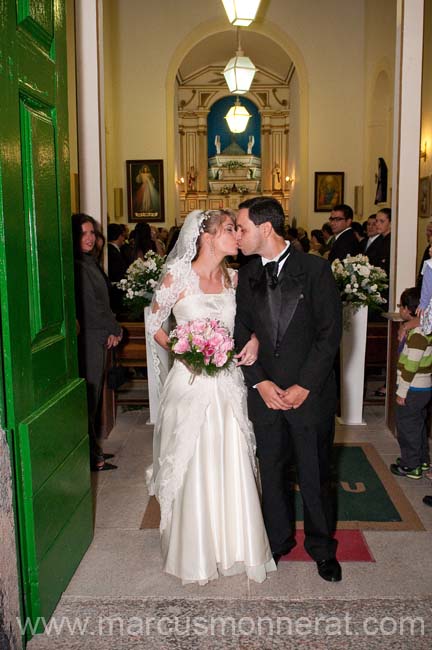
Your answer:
[0,0,92,632]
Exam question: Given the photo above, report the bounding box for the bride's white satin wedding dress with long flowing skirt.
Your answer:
[150,271,276,584]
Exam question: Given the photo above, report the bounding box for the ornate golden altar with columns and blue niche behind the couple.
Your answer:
[176,90,292,218]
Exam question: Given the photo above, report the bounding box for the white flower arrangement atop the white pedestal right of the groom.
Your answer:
[331,255,388,311]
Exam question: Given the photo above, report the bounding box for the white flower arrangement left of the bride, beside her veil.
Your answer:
[115,250,165,318]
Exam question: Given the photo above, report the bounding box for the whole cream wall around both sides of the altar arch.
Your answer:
[104,0,365,227]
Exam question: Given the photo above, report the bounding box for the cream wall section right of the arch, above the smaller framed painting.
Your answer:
[280,0,364,229]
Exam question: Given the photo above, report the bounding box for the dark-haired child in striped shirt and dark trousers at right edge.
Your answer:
[390,287,432,479]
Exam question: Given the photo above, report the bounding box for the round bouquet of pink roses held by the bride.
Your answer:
[168,318,234,376]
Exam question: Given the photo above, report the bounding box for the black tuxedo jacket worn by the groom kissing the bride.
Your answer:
[235,248,342,421]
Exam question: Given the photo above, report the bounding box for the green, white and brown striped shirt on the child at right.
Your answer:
[396,327,432,397]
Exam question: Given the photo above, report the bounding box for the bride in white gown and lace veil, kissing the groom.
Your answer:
[147,210,276,584]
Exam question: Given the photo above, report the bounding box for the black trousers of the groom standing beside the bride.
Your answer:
[252,398,337,561]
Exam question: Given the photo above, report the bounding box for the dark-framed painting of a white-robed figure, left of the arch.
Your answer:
[126,160,165,223]
